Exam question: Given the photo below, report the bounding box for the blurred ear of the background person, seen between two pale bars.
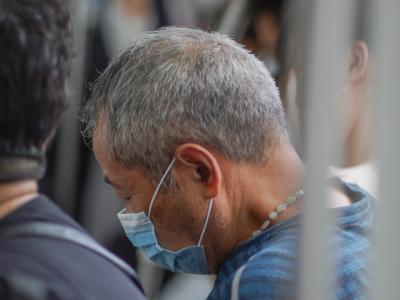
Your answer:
[349,41,369,83]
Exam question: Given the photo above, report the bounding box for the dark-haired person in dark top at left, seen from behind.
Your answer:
[0,0,144,300]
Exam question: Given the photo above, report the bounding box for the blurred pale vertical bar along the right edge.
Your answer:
[370,0,400,300]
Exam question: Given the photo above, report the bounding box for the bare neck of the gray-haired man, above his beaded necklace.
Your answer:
[207,143,304,273]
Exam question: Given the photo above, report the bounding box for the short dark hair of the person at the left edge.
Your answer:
[0,0,71,158]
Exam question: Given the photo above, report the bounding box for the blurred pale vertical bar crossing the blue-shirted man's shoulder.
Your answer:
[299,0,353,300]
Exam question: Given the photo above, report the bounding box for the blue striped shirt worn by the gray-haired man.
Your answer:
[207,183,372,300]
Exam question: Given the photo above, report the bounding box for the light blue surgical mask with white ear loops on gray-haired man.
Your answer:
[118,158,213,274]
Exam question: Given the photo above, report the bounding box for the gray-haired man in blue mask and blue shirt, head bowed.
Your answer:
[83,27,371,299]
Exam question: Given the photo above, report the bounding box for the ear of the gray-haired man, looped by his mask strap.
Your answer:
[175,144,222,199]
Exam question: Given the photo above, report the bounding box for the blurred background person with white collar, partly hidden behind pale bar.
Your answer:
[278,0,377,196]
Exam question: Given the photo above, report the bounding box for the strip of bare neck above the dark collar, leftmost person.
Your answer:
[0,180,38,218]
